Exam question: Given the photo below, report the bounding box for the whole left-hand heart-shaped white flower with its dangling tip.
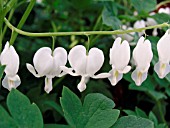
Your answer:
[26,47,67,93]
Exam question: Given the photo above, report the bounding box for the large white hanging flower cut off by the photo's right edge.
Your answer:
[154,29,170,79]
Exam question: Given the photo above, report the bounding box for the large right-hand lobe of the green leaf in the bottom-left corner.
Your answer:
[7,89,43,128]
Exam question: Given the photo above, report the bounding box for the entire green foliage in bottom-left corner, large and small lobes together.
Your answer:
[0,89,43,128]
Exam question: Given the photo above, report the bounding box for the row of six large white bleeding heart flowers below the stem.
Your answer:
[0,29,170,93]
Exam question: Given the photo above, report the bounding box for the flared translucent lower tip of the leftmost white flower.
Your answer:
[2,75,21,91]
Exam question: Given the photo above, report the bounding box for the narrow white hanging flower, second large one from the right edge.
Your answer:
[131,37,153,86]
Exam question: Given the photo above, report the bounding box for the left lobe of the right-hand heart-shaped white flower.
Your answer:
[68,45,87,75]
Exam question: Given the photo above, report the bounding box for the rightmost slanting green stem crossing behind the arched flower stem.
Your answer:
[10,0,36,45]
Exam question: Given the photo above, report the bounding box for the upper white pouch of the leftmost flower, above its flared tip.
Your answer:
[1,42,19,76]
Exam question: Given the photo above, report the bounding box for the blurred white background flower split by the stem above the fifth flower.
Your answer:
[133,20,146,37]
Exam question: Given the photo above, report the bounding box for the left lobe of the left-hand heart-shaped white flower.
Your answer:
[33,47,53,76]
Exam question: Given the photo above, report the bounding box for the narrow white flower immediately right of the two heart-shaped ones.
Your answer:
[109,37,131,85]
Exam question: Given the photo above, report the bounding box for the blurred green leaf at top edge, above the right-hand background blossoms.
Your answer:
[131,0,157,13]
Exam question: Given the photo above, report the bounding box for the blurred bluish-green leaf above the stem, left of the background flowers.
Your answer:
[102,7,121,30]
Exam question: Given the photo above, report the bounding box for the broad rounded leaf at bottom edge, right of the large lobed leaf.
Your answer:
[111,115,154,128]
